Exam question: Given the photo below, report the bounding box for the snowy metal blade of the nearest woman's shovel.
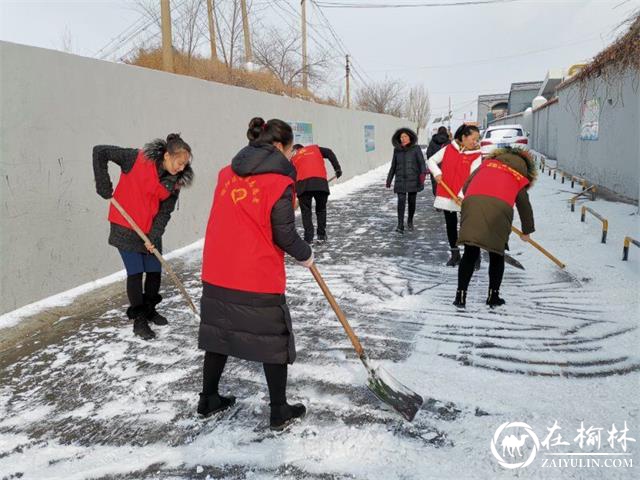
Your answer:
[362,358,423,421]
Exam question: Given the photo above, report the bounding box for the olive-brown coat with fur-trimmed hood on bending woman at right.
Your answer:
[458,149,536,255]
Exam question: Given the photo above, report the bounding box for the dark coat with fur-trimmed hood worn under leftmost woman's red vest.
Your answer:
[93,140,193,253]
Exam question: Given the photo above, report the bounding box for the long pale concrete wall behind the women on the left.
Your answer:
[0,42,407,313]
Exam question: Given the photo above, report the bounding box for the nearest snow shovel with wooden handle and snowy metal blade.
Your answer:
[309,264,423,421]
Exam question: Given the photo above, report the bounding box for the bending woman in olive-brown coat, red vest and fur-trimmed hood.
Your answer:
[453,148,537,308]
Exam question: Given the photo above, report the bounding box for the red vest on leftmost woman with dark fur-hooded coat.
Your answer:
[109,150,171,233]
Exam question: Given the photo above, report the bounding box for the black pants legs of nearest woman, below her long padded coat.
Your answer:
[202,352,287,406]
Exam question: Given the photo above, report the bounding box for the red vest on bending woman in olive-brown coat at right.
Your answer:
[465,160,529,208]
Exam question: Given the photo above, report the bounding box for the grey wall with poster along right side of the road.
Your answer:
[533,67,640,201]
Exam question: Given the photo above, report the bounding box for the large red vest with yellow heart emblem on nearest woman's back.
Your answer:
[202,166,293,294]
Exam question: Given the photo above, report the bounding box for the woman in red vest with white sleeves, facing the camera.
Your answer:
[427,124,482,267]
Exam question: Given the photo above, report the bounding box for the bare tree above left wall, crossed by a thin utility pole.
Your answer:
[253,27,328,88]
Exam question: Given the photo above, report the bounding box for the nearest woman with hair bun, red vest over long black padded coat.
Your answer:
[198,118,313,430]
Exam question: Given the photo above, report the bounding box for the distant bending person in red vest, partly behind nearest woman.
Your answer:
[291,144,342,243]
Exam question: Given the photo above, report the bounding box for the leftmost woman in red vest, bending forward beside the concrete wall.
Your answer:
[93,133,193,340]
